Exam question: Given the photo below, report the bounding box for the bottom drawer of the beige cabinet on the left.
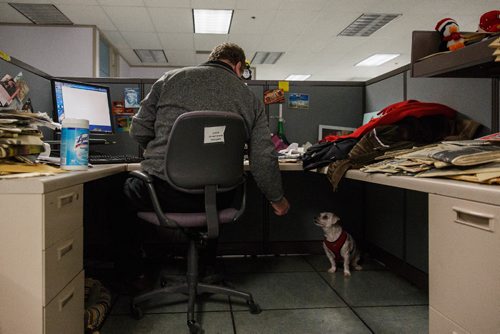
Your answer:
[44,270,85,334]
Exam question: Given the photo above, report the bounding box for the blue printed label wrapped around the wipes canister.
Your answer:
[61,128,89,166]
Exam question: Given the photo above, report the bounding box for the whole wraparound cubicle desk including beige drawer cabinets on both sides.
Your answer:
[0,164,500,334]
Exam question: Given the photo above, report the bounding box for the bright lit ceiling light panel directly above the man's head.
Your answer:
[193,9,233,34]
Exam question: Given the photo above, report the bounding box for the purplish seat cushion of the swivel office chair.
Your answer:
[137,208,238,227]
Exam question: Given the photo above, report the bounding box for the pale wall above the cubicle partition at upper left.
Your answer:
[0,25,95,77]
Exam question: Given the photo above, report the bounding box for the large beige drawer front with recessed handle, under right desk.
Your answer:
[429,195,500,334]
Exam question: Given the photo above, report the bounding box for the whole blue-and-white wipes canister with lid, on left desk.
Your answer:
[61,118,89,170]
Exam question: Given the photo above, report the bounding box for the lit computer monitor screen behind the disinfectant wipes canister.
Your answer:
[52,79,113,134]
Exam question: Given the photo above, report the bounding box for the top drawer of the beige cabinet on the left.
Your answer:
[43,184,83,249]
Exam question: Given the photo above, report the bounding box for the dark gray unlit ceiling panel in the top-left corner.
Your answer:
[9,2,73,24]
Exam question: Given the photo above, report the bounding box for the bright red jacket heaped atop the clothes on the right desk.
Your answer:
[324,100,457,141]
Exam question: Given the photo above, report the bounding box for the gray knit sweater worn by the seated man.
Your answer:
[130,62,283,201]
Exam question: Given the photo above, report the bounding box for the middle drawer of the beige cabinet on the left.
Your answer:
[43,227,83,305]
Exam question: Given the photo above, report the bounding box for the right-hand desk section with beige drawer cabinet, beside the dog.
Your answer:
[346,170,500,334]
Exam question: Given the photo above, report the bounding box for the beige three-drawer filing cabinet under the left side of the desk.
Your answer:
[0,184,84,334]
